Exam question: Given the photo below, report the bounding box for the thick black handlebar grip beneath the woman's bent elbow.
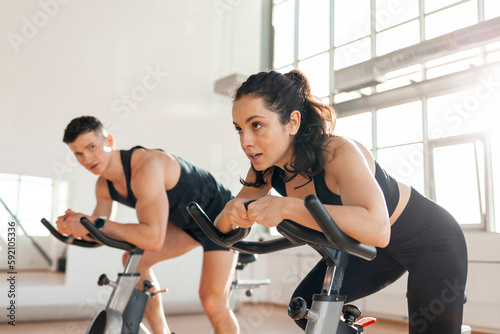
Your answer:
[304,195,377,261]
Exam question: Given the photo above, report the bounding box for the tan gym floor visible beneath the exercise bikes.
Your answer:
[0,304,408,334]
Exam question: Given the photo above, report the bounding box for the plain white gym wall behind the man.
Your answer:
[0,0,261,322]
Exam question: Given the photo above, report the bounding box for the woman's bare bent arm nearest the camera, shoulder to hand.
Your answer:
[248,138,390,247]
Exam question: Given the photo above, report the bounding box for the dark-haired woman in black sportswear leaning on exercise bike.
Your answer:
[216,70,467,334]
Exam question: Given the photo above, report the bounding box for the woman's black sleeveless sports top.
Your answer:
[271,161,399,217]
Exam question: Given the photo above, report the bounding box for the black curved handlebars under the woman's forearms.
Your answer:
[187,195,377,260]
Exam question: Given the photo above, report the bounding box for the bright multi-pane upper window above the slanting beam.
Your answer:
[272,0,500,96]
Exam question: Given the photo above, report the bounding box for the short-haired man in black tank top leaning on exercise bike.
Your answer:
[57,116,238,334]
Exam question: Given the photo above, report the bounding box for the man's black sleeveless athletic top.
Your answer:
[108,146,233,228]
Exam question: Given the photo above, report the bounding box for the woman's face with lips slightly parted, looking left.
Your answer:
[233,96,296,171]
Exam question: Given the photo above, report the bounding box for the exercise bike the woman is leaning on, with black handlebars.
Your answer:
[187,195,471,334]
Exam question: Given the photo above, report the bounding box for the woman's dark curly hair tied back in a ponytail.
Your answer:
[234,70,336,188]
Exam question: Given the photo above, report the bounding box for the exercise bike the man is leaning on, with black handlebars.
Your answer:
[41,217,158,334]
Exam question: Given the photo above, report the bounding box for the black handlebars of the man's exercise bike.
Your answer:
[41,217,142,253]
